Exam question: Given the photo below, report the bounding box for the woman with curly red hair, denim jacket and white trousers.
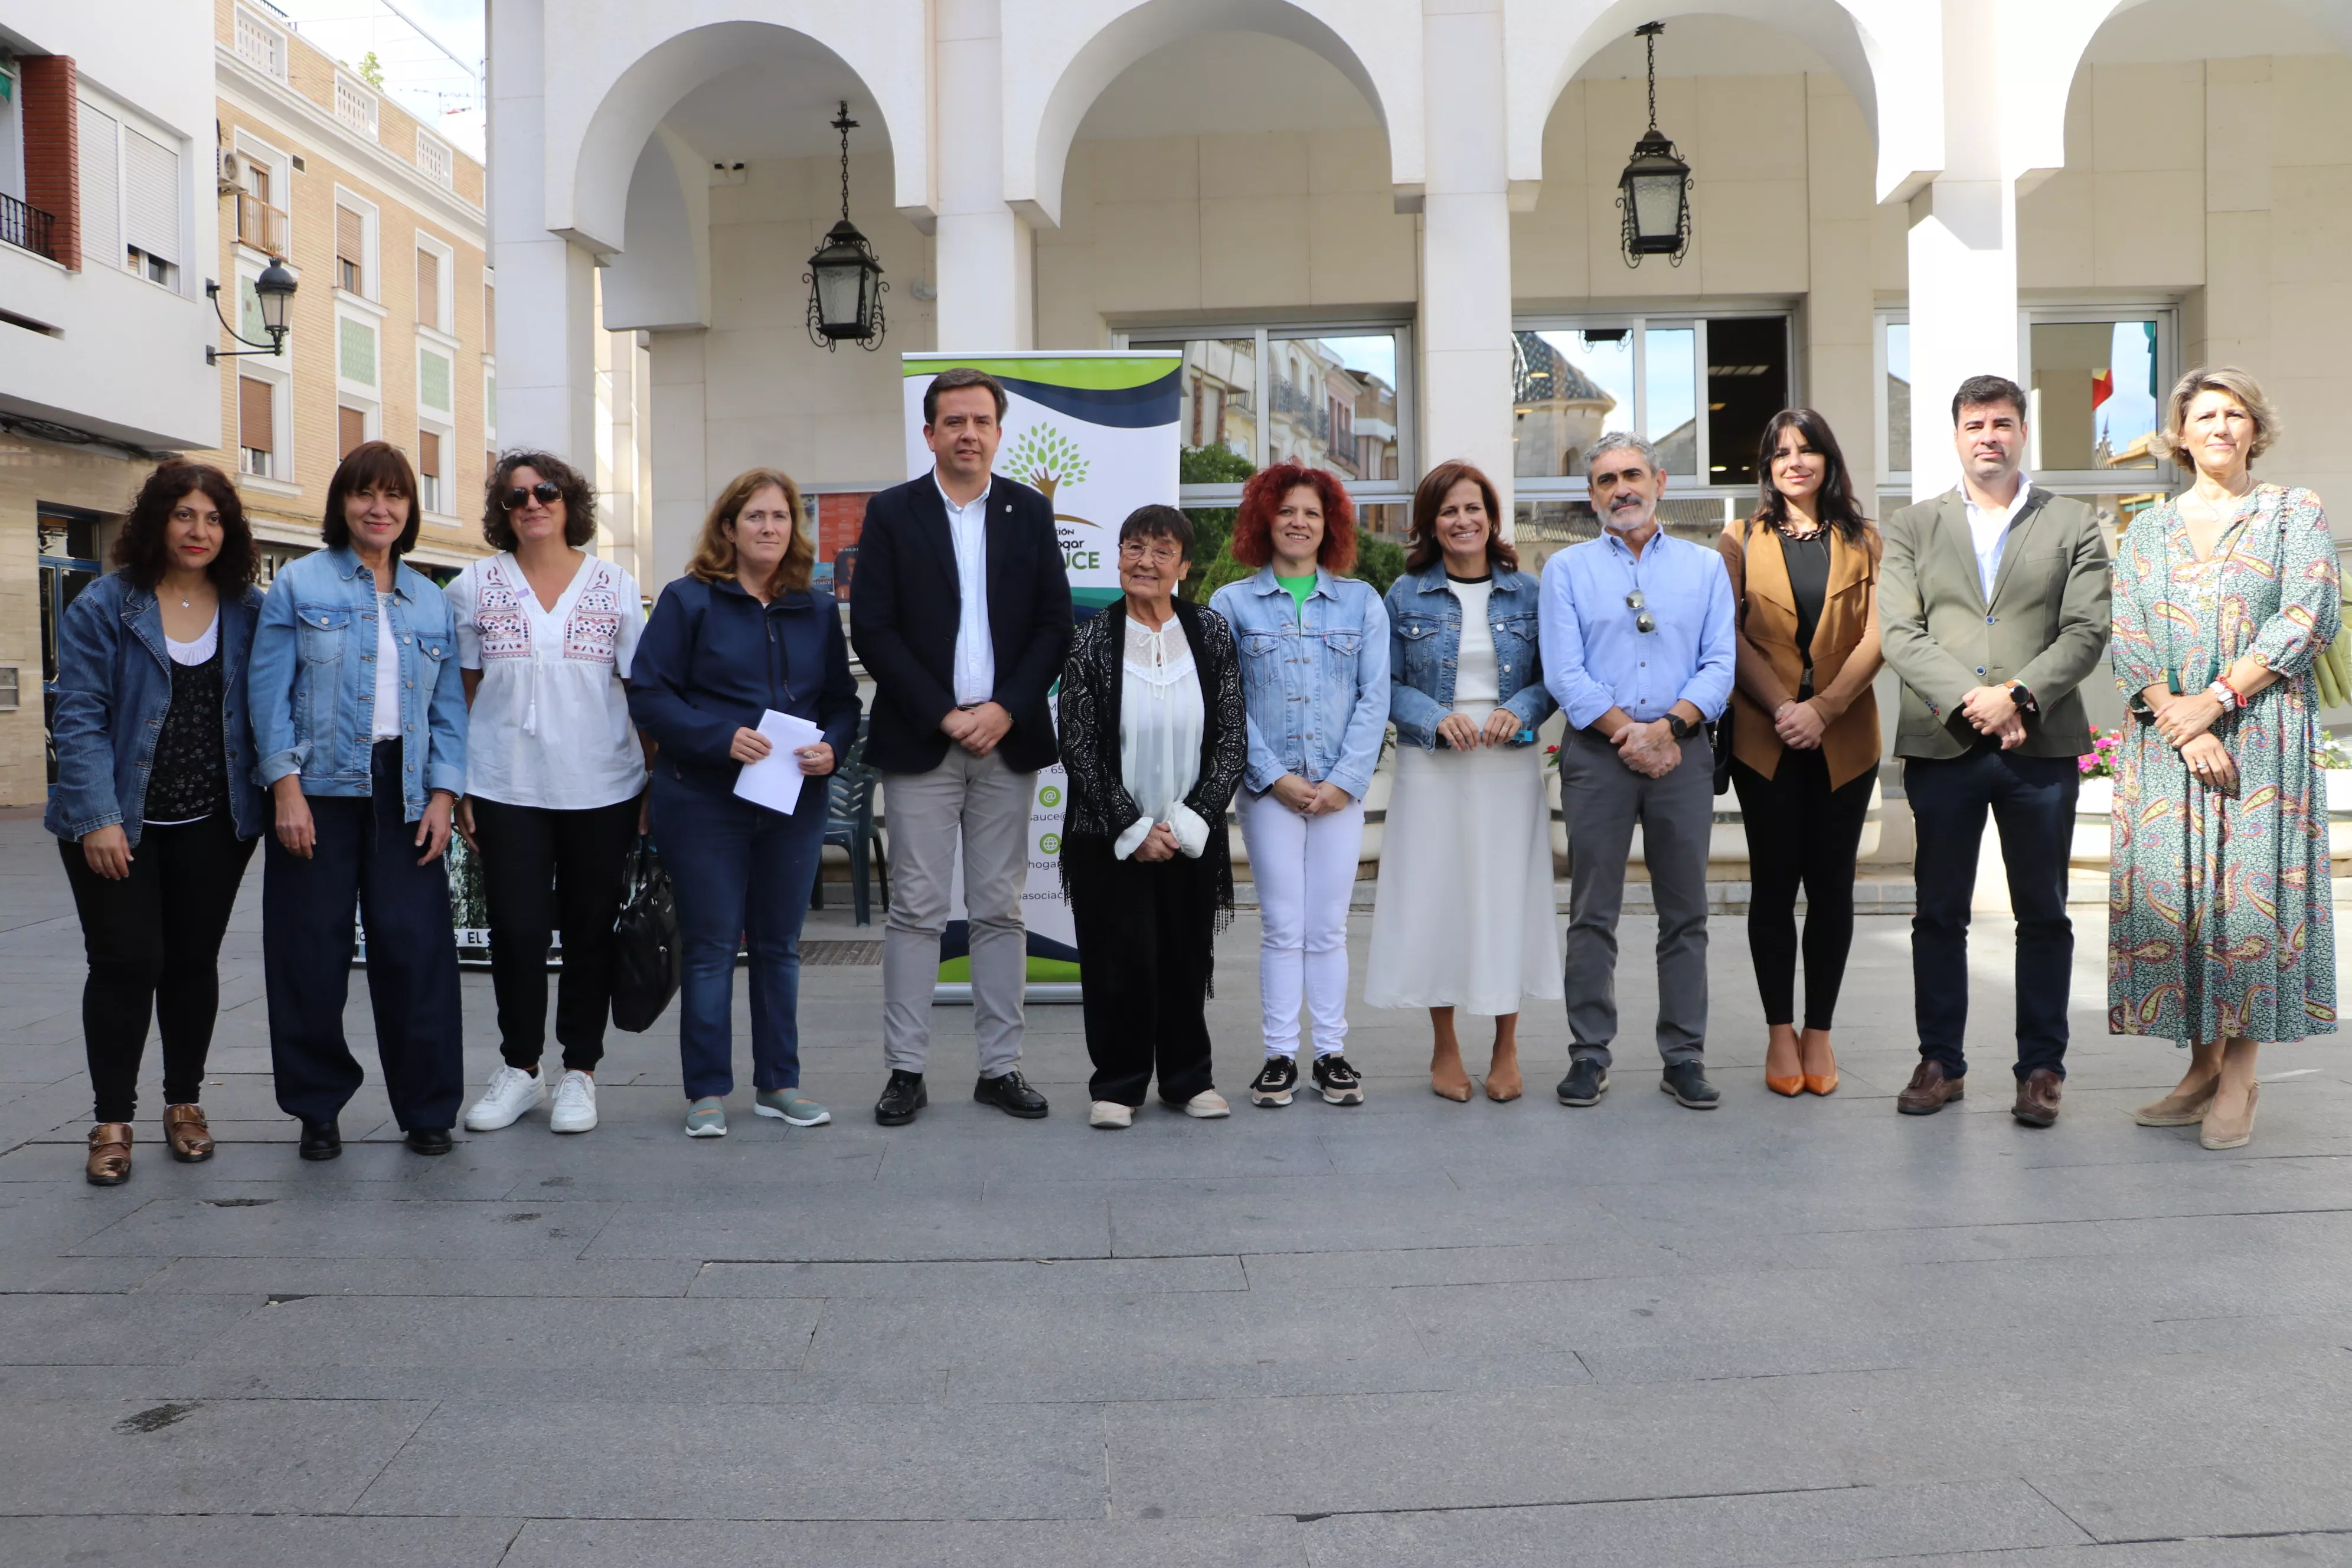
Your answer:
[1211,463,1388,1105]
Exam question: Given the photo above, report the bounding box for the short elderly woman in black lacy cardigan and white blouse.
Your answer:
[1059,505,1249,1128]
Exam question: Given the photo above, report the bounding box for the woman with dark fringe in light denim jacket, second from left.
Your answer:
[247,442,466,1159]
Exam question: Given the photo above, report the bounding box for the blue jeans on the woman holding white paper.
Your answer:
[654,762,825,1100]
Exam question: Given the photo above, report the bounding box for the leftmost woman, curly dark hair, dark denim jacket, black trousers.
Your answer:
[45,460,263,1187]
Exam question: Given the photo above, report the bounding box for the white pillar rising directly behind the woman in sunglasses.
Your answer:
[489,0,595,465]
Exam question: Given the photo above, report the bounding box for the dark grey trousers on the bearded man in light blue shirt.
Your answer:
[1559,729,1714,1067]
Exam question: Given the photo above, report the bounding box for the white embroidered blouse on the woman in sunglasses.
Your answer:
[442,553,645,811]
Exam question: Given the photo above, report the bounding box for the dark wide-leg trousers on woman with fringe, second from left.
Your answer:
[261,740,466,1131]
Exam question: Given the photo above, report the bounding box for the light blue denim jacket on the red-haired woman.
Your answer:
[1209,567,1388,799]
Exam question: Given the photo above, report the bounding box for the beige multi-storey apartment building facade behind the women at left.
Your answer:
[205,0,499,571]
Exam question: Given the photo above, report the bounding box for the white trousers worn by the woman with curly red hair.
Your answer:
[1235,790,1364,1056]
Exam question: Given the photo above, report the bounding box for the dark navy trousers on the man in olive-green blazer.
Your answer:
[1903,743,2082,1082]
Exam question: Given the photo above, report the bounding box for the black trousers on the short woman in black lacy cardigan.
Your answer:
[1063,847,1216,1105]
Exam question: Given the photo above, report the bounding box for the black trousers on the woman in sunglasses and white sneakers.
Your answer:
[473,795,638,1072]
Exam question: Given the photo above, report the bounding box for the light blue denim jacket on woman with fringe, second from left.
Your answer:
[247,548,466,823]
